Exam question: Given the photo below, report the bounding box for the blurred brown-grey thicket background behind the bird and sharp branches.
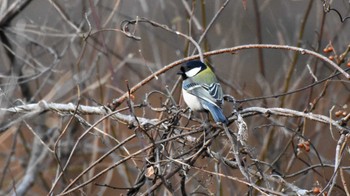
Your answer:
[0,0,350,195]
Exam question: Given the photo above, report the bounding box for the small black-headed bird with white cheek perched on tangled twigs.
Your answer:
[177,60,228,125]
